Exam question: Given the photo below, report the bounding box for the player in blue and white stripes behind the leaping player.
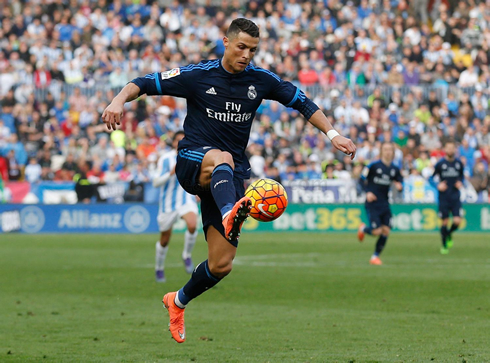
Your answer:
[153,131,198,282]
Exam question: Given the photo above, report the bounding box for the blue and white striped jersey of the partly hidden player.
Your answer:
[153,150,196,213]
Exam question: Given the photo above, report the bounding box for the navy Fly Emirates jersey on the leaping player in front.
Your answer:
[131,59,318,178]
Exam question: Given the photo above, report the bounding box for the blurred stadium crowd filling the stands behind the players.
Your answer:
[0,0,490,199]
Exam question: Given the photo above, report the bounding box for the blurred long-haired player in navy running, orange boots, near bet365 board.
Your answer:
[357,142,403,265]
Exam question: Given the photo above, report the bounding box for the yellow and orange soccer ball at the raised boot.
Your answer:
[245,179,288,222]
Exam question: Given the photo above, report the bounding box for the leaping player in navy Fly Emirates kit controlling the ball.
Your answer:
[102,18,356,343]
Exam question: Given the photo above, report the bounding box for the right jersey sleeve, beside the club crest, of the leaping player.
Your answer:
[266,71,319,120]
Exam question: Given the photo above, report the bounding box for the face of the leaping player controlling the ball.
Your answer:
[223,32,259,73]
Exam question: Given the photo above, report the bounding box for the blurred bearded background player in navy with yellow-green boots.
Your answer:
[429,141,464,255]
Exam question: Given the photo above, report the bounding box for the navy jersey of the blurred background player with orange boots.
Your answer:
[361,160,403,205]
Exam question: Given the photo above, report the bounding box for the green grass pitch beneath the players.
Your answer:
[0,233,490,362]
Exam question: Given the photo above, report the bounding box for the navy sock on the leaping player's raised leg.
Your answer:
[210,163,236,216]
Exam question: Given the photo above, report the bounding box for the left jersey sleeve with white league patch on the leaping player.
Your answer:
[131,68,193,98]
